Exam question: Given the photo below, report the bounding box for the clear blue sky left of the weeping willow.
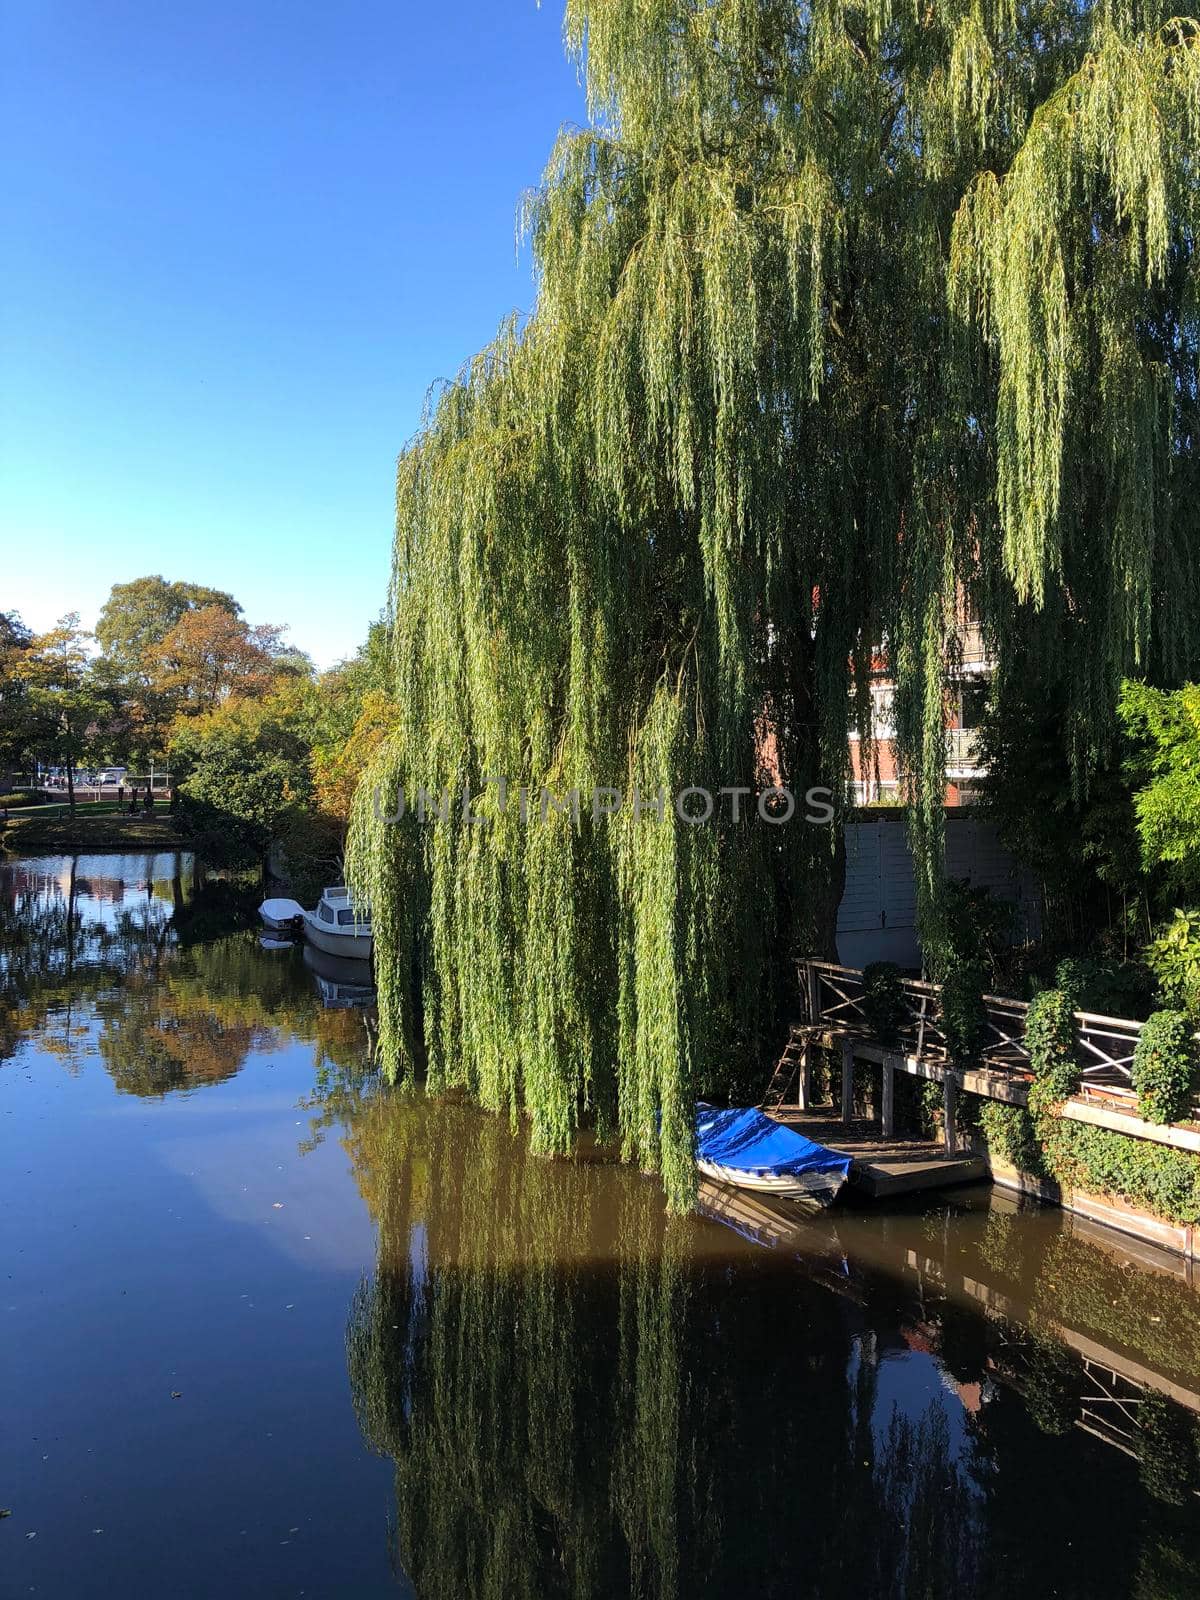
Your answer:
[0,0,584,666]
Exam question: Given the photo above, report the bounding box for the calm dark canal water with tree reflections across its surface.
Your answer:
[0,856,1200,1600]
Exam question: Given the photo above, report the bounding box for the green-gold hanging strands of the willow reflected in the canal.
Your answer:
[349,1101,700,1600]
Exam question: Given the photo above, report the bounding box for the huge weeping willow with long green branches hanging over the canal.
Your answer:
[349,0,1200,1205]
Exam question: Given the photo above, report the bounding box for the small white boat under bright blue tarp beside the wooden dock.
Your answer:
[696,1104,853,1205]
